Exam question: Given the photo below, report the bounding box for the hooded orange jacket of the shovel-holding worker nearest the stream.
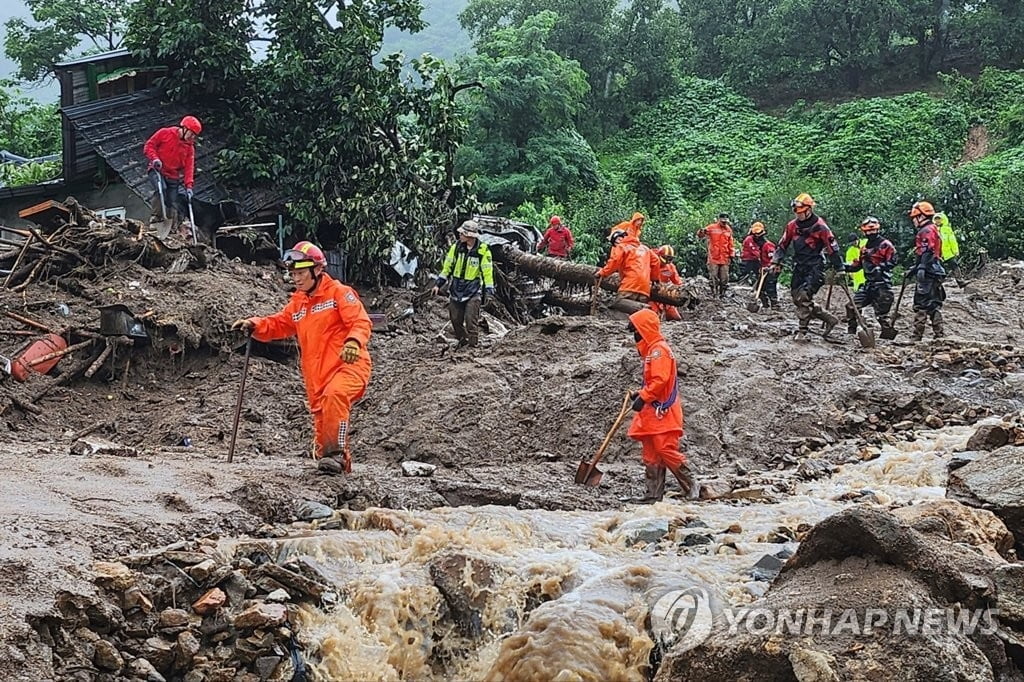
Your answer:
[629,308,683,439]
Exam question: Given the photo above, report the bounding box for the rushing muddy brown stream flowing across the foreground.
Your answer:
[214,426,975,680]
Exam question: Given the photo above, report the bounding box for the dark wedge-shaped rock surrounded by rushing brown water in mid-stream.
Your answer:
[429,554,494,638]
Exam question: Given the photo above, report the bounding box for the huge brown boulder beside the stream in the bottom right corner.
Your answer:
[655,507,1024,682]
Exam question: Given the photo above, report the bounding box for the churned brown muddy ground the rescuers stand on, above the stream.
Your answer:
[0,232,1024,680]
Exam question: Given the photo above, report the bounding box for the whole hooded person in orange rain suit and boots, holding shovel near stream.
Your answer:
[627,308,693,503]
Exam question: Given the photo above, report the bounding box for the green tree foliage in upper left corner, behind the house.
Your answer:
[4,0,125,81]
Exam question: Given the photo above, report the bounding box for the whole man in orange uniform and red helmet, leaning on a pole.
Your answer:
[231,242,372,474]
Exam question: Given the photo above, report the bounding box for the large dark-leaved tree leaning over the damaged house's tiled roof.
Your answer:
[127,0,476,281]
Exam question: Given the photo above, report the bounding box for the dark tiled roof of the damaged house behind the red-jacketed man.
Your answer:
[61,89,283,217]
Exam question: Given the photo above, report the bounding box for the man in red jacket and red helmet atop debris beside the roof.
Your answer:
[142,116,203,232]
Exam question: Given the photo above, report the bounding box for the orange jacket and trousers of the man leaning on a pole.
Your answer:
[253,272,373,464]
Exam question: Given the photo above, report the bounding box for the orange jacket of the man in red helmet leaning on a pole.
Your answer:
[253,273,373,412]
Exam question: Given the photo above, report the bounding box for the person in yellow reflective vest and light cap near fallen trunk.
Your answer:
[433,220,495,348]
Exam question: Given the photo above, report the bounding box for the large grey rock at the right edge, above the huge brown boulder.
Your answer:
[946,446,1024,554]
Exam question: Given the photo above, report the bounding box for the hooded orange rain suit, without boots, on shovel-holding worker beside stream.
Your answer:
[629,308,686,469]
